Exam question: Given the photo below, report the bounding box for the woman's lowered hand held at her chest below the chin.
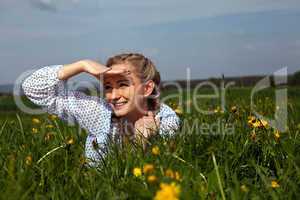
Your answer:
[134,111,159,148]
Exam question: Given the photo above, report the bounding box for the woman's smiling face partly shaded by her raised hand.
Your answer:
[103,63,144,117]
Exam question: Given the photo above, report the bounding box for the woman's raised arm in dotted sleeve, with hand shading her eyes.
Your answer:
[22,60,123,166]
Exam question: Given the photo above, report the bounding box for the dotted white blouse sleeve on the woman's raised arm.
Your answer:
[22,65,111,161]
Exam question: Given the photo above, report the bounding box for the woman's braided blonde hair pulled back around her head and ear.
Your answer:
[106,53,160,110]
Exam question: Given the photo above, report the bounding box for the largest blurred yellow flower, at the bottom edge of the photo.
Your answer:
[154,182,180,200]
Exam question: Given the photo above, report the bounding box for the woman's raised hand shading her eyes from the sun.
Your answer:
[80,60,127,80]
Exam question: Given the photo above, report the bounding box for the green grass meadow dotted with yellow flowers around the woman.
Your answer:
[0,88,300,199]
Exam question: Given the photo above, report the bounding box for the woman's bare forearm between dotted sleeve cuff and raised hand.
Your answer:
[57,61,85,80]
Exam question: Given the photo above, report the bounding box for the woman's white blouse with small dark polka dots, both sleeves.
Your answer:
[22,65,180,166]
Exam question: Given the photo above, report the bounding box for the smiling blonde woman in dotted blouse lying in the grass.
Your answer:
[22,53,179,166]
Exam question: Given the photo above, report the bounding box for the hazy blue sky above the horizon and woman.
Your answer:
[0,0,300,84]
